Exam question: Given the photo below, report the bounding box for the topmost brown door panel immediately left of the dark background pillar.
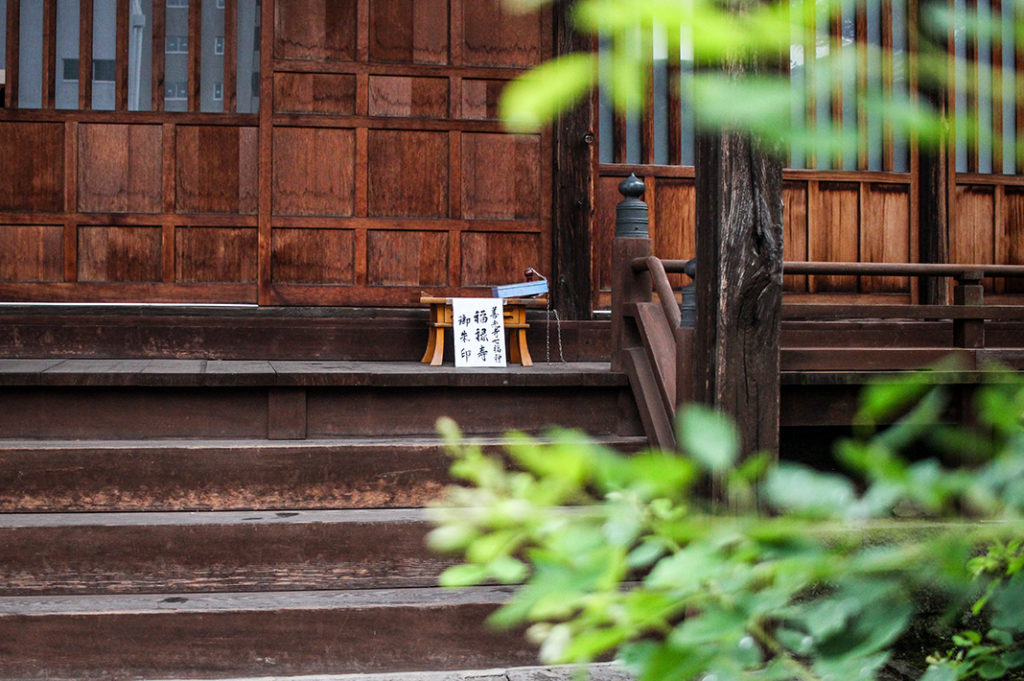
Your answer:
[462,0,542,67]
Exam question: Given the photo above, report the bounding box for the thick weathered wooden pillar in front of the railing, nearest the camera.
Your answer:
[693,125,782,453]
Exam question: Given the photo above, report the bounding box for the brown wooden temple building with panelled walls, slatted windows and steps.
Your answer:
[0,0,1024,680]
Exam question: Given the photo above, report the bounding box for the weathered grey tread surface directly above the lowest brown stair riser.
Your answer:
[0,587,515,619]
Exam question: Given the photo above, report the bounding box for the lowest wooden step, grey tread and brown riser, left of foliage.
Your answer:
[0,587,536,681]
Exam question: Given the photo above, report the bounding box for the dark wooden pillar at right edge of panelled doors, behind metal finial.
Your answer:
[551,0,595,320]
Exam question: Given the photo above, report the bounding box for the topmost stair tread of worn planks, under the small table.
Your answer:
[0,358,627,387]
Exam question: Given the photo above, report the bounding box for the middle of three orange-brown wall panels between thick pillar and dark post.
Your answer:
[807,182,860,293]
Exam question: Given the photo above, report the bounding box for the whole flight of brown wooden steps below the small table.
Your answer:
[0,358,646,681]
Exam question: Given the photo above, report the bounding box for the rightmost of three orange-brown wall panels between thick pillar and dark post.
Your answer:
[860,183,910,293]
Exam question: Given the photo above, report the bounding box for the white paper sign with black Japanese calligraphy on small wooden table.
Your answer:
[452,298,505,367]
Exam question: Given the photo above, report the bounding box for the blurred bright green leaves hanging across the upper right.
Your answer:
[501,0,1007,154]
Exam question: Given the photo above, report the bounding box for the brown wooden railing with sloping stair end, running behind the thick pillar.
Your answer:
[611,173,1024,448]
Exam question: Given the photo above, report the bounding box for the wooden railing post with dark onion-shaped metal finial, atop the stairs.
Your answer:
[611,175,651,371]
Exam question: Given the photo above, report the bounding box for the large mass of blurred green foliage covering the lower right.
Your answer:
[429,372,1024,681]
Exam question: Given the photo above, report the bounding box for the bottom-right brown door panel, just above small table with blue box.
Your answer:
[461,231,541,286]
